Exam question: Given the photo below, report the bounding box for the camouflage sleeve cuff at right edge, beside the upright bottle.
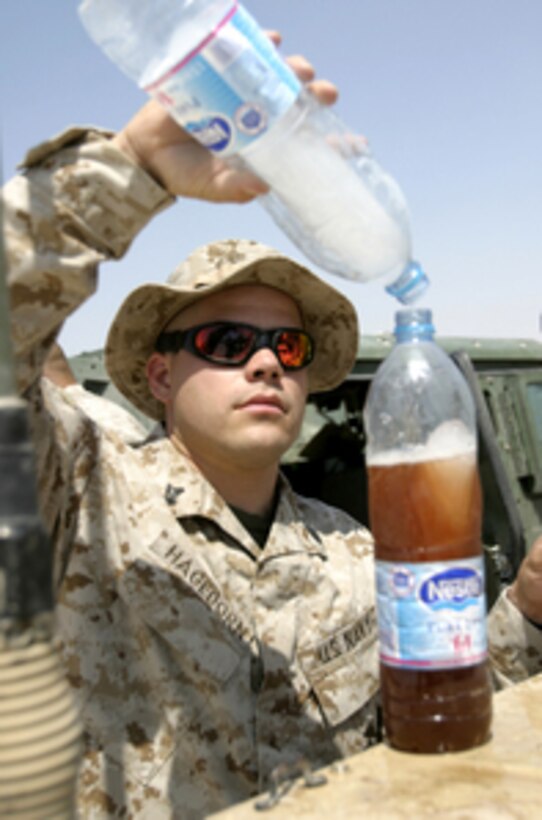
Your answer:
[488,590,542,686]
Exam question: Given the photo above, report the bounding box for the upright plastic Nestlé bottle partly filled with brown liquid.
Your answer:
[365,309,491,752]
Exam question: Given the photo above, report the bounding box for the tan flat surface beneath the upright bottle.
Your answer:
[213,675,542,820]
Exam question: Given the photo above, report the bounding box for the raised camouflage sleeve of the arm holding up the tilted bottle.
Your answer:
[3,128,172,391]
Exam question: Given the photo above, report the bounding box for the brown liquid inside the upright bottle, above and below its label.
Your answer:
[368,453,491,752]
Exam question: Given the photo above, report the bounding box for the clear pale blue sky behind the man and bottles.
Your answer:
[0,0,542,354]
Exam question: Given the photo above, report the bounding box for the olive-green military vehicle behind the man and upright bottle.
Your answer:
[70,335,542,606]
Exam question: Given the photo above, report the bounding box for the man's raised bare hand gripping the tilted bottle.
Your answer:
[113,32,338,202]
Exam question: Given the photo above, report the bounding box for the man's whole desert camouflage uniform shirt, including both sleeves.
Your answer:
[2,130,542,820]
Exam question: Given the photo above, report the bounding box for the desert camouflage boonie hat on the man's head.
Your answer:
[105,240,358,420]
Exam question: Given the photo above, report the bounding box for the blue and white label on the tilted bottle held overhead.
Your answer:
[145,4,301,156]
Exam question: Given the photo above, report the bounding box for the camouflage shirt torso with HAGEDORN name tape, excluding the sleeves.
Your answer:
[28,385,378,817]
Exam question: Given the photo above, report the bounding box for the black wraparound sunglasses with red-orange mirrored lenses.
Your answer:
[156,322,314,370]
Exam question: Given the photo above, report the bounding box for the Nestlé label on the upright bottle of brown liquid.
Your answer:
[376,556,487,670]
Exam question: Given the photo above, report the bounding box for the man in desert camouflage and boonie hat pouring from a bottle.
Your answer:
[5,56,542,818]
